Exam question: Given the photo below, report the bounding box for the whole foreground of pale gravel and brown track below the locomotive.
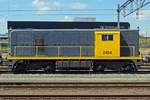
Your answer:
[0,74,150,100]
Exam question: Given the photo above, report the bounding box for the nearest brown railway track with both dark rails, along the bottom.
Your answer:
[0,82,150,100]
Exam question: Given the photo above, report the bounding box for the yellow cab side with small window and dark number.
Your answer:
[95,31,120,58]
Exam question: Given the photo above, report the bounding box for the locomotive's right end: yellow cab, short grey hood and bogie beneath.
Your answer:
[94,30,141,71]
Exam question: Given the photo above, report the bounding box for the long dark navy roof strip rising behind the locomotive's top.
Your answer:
[7,21,130,29]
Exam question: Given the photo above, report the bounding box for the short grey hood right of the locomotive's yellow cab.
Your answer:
[120,30,139,56]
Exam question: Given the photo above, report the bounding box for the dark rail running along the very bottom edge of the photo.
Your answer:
[0,95,150,100]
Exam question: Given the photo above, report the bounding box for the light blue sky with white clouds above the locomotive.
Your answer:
[0,0,150,34]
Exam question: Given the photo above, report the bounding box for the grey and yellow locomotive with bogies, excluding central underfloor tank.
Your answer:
[8,29,141,71]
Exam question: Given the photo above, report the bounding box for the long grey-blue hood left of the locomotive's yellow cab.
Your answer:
[10,30,94,57]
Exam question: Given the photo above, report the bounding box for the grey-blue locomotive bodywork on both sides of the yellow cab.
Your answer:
[9,29,139,57]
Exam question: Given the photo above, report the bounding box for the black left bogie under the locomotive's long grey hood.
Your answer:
[12,60,55,73]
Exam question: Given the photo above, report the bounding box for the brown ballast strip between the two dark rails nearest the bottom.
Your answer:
[0,83,150,97]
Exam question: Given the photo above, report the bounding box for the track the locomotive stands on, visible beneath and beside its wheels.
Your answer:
[0,65,150,74]
